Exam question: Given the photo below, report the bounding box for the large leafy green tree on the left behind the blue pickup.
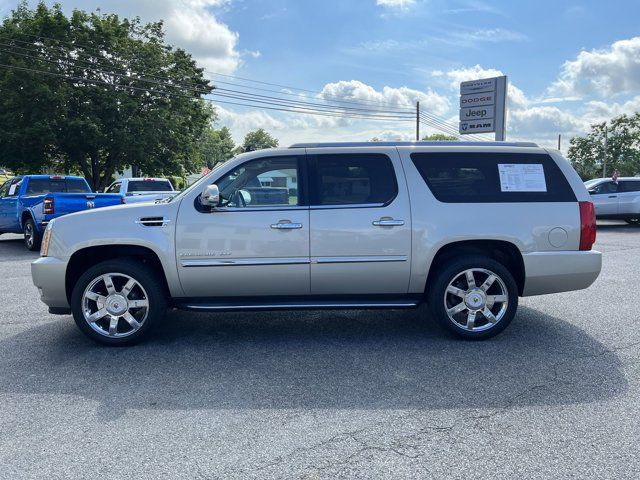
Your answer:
[0,1,213,190]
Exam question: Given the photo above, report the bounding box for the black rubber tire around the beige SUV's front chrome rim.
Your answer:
[71,258,167,346]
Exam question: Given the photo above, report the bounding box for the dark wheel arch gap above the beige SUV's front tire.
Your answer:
[65,244,170,303]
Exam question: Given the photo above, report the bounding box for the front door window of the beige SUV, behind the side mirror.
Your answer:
[217,157,300,208]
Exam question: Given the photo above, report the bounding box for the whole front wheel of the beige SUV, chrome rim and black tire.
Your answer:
[71,259,167,345]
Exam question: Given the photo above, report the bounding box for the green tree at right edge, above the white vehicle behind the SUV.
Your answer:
[568,112,640,180]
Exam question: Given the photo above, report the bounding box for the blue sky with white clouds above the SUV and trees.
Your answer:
[0,0,640,147]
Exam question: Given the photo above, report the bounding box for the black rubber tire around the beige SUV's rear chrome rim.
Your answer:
[427,255,518,340]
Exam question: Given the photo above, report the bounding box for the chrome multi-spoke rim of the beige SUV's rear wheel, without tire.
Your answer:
[444,268,509,332]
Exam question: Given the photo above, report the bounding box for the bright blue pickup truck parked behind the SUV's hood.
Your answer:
[0,175,124,250]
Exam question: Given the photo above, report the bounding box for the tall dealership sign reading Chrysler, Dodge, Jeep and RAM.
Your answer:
[459,77,507,140]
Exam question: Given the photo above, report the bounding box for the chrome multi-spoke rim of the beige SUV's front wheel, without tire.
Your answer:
[82,273,149,338]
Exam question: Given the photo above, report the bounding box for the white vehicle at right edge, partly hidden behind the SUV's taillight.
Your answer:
[584,177,640,224]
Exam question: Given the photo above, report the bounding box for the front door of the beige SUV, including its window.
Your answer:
[176,152,310,297]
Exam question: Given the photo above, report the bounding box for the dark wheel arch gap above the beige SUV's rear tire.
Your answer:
[425,239,525,295]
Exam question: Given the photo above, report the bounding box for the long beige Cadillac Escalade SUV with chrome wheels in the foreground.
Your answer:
[32,142,601,345]
